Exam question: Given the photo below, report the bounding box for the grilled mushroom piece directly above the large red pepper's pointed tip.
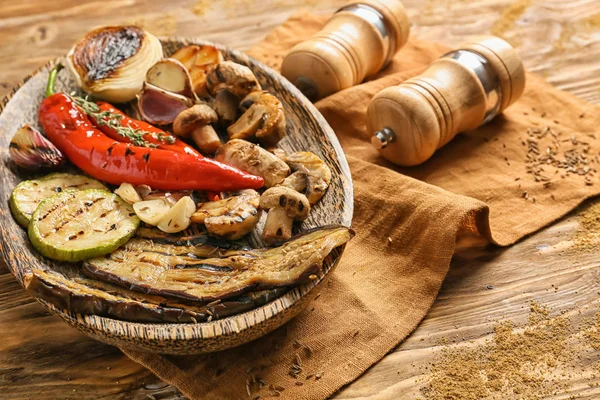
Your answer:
[215,139,290,188]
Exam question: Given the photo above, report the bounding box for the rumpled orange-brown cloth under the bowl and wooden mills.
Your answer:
[124,14,600,399]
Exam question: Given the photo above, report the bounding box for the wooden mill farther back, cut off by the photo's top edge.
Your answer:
[281,0,410,101]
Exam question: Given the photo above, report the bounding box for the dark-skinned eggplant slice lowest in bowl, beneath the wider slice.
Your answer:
[23,270,285,323]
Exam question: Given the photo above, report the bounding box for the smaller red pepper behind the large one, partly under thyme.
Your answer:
[90,101,204,158]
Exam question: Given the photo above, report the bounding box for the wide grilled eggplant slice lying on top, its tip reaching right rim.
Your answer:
[83,227,353,301]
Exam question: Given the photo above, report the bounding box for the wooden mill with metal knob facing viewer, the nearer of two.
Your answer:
[367,36,525,166]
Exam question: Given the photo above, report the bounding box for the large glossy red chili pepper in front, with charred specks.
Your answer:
[39,93,264,192]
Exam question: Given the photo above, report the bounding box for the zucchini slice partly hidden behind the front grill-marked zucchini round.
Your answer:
[10,173,106,228]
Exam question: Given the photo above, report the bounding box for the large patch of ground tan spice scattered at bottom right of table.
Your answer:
[421,303,573,400]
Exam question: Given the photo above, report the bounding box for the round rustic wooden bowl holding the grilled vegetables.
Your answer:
[0,38,353,354]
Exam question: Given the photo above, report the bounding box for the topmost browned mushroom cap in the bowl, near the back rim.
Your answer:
[206,61,261,98]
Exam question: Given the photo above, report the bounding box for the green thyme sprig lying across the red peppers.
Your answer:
[71,96,175,148]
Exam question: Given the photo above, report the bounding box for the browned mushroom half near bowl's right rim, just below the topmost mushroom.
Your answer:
[227,91,286,145]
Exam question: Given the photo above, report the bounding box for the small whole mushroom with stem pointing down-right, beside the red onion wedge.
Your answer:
[173,104,221,153]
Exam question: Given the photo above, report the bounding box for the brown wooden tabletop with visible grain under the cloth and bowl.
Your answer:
[0,0,600,399]
